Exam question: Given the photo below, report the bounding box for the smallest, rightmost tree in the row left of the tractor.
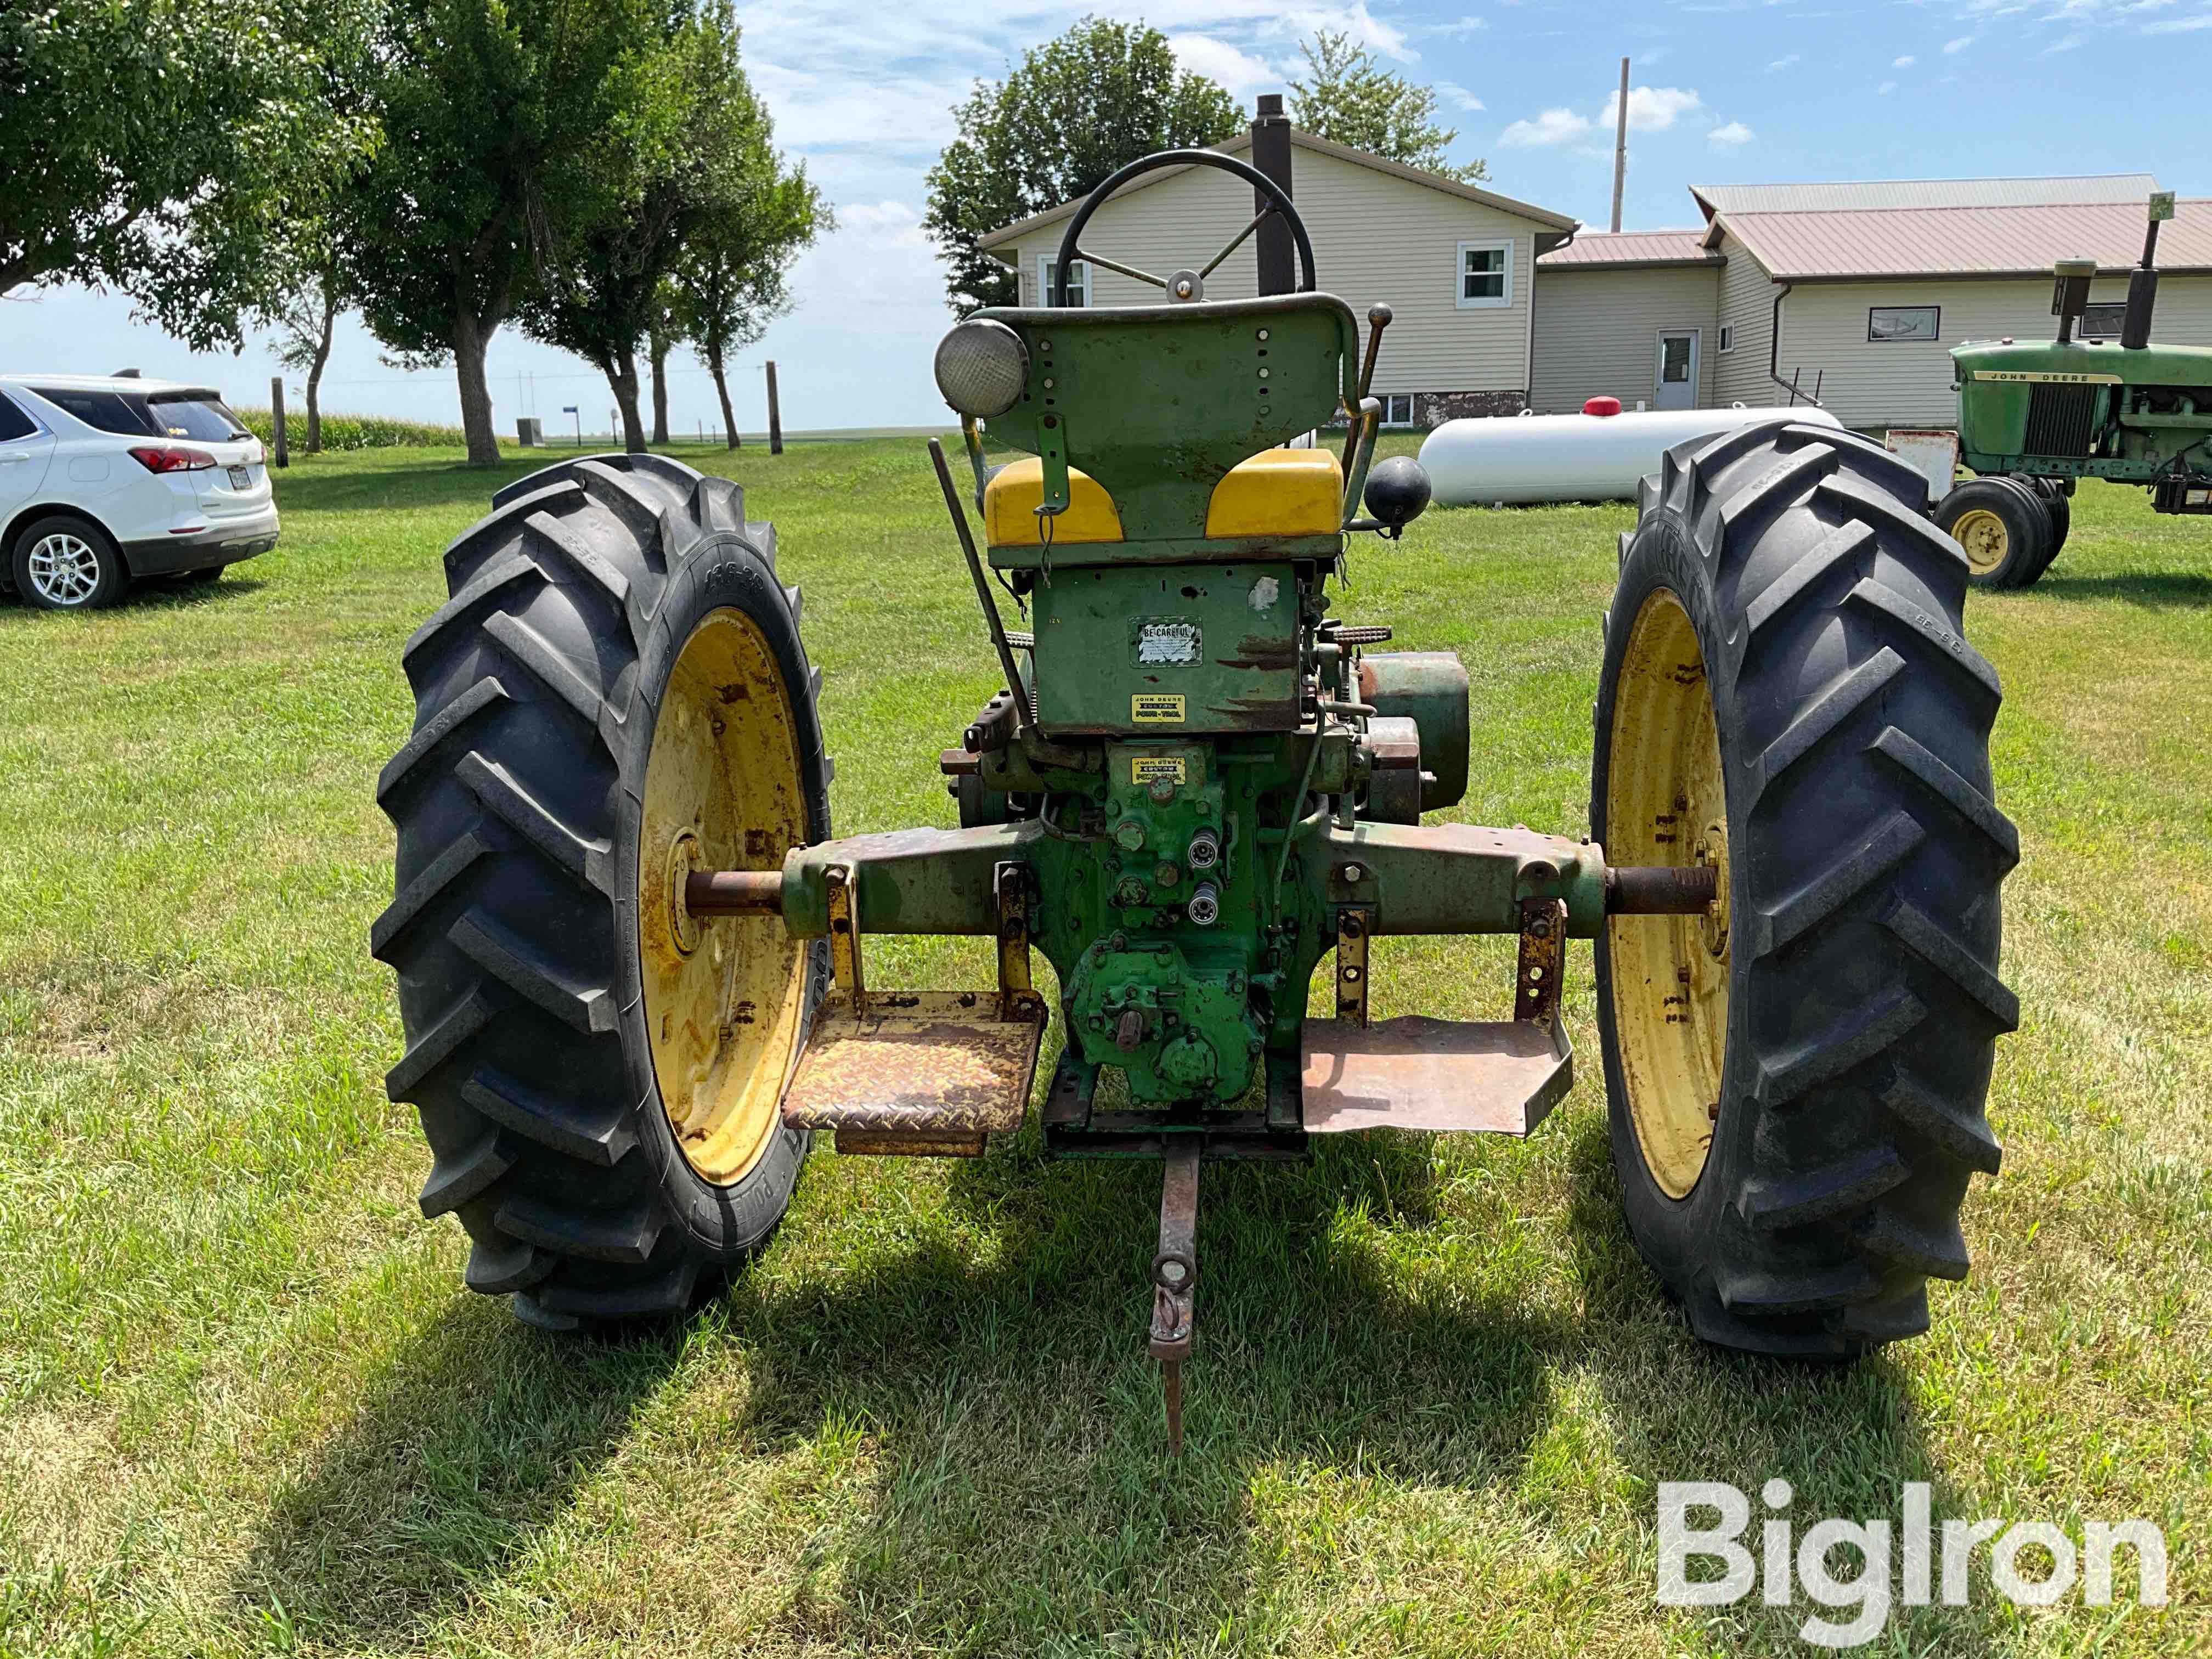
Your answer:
[673,157,836,449]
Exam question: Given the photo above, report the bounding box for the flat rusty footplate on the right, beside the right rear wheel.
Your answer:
[1301,1015,1575,1135]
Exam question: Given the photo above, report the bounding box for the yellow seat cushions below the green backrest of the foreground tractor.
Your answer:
[982,449,1345,546]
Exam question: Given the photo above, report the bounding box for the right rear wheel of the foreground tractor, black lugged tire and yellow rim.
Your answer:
[1590,422,2017,1356]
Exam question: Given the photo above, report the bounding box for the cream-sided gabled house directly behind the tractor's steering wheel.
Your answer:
[982,131,1575,427]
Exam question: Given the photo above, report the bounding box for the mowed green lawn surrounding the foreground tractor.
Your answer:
[0,440,2212,1657]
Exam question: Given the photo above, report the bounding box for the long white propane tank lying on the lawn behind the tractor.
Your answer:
[1420,398,1843,506]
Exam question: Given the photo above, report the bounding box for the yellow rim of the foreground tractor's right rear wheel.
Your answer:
[1606,589,1730,1199]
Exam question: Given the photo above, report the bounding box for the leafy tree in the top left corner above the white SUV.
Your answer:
[0,0,376,349]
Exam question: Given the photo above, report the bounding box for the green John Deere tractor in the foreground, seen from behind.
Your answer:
[374,150,2015,1423]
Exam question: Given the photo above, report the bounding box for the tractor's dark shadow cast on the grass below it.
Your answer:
[239,1124,2008,1652]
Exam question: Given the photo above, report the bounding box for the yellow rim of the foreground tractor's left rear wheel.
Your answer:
[637,611,808,1186]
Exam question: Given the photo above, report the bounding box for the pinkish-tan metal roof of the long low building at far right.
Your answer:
[1706,197,2212,283]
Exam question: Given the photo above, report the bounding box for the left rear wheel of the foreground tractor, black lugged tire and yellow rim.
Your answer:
[371,456,830,1329]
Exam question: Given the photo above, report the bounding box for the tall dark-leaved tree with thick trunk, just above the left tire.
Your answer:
[343,0,668,465]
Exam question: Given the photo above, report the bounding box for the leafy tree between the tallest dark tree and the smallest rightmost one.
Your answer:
[522,0,805,452]
